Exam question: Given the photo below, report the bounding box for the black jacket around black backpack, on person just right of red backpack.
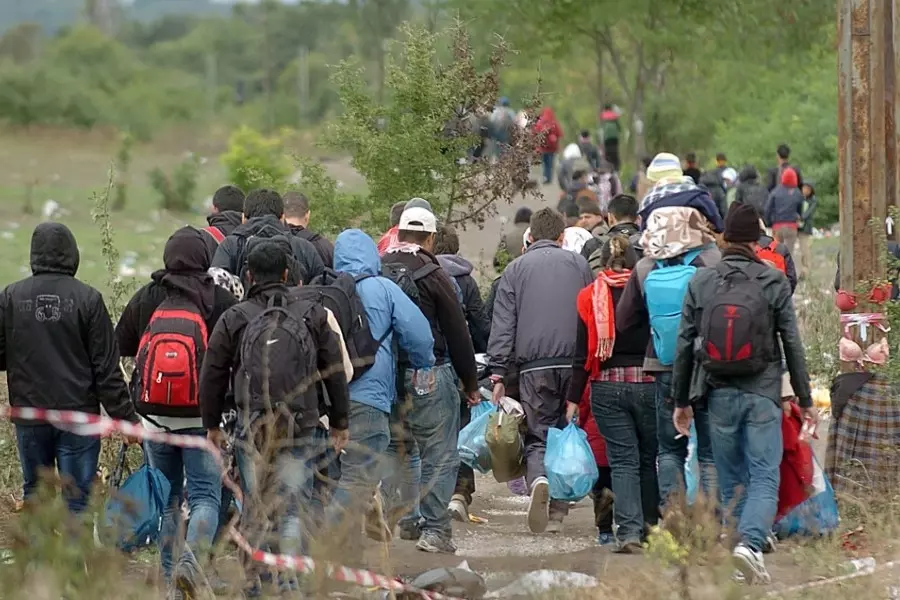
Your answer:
[200,283,350,429]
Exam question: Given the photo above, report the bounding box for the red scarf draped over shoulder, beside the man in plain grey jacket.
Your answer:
[578,269,631,375]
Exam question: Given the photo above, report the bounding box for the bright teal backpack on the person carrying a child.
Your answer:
[644,248,705,366]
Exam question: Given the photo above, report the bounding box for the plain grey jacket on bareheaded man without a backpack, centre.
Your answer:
[488,240,594,375]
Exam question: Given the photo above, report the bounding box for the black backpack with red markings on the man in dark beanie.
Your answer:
[699,261,776,377]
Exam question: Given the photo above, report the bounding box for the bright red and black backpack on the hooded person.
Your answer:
[134,298,208,418]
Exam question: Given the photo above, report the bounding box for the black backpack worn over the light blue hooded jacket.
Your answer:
[291,269,391,381]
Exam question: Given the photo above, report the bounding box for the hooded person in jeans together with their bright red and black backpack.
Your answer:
[116,227,237,598]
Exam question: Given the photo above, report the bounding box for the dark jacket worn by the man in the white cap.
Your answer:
[381,249,478,392]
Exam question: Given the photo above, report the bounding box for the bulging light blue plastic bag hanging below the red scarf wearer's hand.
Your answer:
[544,423,600,502]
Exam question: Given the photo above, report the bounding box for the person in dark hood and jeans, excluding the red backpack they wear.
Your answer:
[116,227,237,590]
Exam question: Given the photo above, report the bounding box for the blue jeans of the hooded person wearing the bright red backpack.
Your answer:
[145,429,222,581]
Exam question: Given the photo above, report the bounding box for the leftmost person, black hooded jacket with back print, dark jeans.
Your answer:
[0,223,137,513]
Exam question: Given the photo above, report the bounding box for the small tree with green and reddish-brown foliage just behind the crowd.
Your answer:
[328,23,536,226]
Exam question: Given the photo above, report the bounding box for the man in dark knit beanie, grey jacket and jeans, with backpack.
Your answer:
[671,204,818,584]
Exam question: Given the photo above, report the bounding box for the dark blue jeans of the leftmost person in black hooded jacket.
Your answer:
[16,425,100,514]
